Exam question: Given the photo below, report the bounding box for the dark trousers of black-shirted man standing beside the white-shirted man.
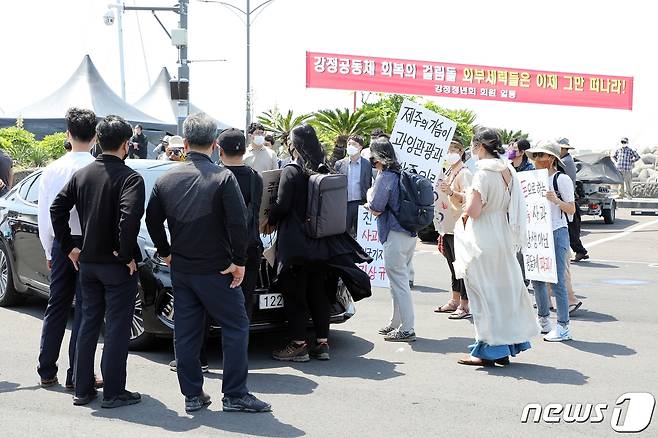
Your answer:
[75,263,138,399]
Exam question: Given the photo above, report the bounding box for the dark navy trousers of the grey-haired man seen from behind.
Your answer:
[171,271,249,397]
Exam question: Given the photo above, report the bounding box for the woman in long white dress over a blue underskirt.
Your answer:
[454,128,539,366]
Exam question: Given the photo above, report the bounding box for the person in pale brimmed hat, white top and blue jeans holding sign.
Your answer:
[526,141,576,342]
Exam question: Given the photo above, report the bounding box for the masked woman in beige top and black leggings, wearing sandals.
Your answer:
[434,140,473,319]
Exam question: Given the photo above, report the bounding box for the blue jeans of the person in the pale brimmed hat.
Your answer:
[532,227,569,326]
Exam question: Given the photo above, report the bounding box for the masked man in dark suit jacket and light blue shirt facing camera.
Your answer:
[335,135,372,237]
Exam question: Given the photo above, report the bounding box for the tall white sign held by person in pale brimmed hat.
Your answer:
[518,169,557,283]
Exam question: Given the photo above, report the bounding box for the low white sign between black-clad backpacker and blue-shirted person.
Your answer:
[356,205,389,287]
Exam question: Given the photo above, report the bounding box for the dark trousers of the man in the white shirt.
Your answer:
[37,237,82,385]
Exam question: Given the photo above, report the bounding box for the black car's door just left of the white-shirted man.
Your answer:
[9,172,50,293]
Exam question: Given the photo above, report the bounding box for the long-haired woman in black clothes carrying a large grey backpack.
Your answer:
[266,125,372,362]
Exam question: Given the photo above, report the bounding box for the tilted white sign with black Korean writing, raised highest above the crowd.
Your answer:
[391,100,457,183]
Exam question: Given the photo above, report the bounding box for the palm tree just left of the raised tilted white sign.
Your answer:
[311,108,380,165]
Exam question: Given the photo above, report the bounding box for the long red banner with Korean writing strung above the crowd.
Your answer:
[306,52,633,110]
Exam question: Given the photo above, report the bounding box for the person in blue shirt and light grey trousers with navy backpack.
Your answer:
[366,137,416,342]
